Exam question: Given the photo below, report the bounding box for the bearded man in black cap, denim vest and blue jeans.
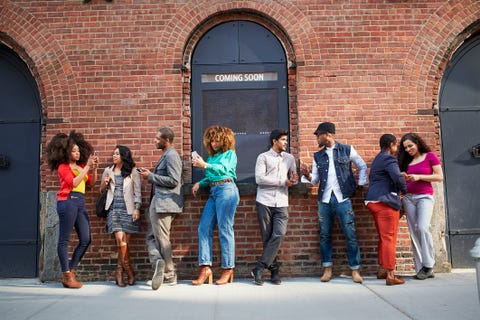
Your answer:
[301,122,367,283]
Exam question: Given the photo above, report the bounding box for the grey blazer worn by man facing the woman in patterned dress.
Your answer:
[148,147,183,213]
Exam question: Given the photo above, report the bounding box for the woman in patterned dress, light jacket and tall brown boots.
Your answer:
[100,145,142,287]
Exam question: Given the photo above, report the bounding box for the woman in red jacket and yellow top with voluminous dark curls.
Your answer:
[46,131,98,289]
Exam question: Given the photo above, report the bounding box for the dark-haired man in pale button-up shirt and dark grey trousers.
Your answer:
[252,129,298,285]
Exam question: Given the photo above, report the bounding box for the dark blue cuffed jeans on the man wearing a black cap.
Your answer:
[318,193,360,270]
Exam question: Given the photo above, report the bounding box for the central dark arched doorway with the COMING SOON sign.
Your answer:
[191,20,289,182]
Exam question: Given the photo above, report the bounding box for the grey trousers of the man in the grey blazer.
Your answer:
[147,206,175,279]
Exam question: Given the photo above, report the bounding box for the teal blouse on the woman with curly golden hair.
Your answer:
[200,150,237,187]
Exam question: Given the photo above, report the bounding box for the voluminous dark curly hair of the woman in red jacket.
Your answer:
[46,130,93,171]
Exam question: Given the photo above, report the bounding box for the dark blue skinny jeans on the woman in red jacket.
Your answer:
[57,192,91,272]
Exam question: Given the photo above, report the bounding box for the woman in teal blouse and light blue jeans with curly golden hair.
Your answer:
[192,126,240,285]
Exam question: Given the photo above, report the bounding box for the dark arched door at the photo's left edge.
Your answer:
[0,44,41,278]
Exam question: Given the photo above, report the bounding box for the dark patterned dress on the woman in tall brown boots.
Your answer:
[105,175,140,233]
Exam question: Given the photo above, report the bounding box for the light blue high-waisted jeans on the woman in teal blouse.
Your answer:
[198,182,240,269]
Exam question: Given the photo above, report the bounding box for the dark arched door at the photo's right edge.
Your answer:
[439,35,480,268]
